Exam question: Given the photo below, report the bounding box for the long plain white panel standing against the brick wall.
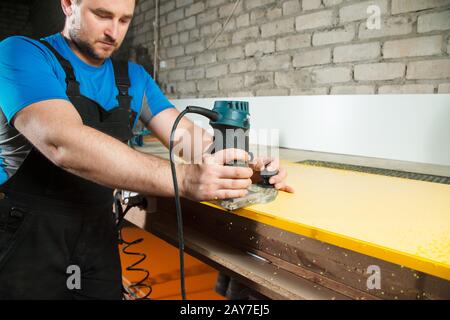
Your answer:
[172,94,450,165]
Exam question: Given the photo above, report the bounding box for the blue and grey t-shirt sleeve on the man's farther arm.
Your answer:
[140,66,174,124]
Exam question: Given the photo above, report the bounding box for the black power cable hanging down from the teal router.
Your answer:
[169,106,219,300]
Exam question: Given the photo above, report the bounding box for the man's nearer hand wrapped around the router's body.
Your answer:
[177,149,253,201]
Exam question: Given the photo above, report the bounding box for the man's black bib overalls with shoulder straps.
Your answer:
[0,41,136,299]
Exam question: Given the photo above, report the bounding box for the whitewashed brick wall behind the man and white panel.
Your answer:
[126,0,450,98]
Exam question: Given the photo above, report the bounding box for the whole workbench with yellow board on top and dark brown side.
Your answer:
[128,142,450,299]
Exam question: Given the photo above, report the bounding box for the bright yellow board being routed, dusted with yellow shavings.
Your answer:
[207,161,450,280]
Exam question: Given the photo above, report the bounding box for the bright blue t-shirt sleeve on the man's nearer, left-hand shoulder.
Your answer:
[0,37,68,123]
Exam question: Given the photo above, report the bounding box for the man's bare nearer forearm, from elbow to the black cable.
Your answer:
[56,126,174,196]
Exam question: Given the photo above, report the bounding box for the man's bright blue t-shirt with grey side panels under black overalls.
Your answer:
[0,33,173,184]
